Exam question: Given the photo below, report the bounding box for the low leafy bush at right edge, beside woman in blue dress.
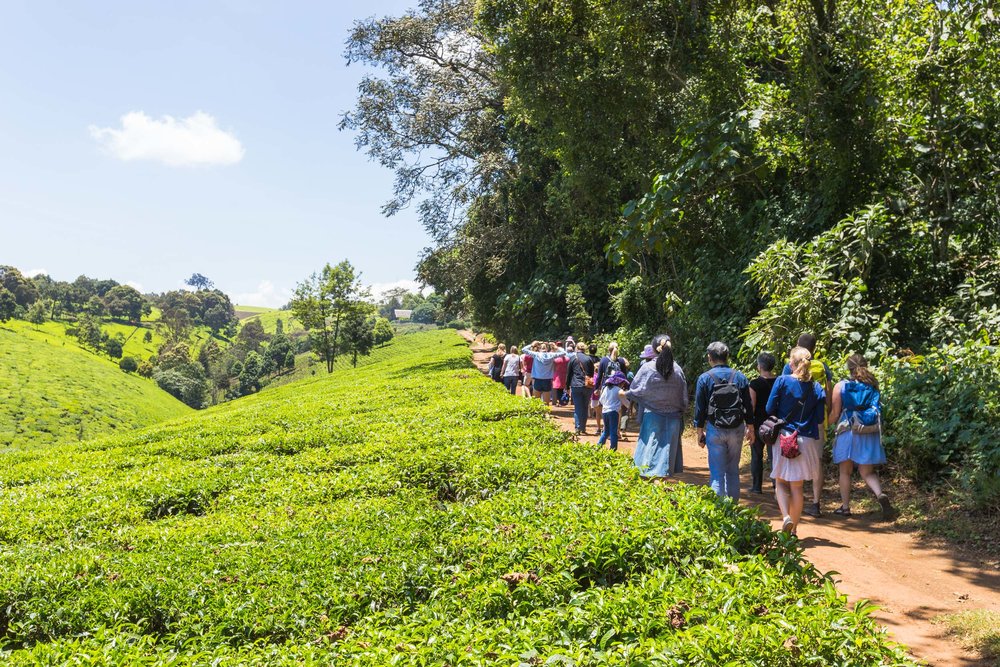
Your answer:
[883,341,1000,508]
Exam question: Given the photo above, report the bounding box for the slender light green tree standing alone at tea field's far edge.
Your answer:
[291,260,370,373]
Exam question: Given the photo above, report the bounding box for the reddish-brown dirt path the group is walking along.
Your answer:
[463,332,1000,667]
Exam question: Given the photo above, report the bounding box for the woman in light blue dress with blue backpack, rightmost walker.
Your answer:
[830,354,893,519]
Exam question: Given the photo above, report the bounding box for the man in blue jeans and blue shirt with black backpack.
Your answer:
[694,341,753,501]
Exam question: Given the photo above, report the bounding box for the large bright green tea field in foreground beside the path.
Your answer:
[0,331,913,666]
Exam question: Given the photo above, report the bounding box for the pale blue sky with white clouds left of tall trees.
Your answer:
[0,0,428,305]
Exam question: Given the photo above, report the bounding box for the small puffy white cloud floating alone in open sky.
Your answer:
[89,111,245,167]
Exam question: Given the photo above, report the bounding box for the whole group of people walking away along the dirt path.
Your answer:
[487,334,893,535]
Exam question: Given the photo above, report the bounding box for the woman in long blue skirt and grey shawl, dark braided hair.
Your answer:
[625,334,688,480]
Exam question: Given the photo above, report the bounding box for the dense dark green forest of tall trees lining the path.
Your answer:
[342,0,1000,505]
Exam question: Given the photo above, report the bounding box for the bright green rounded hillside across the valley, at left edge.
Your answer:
[0,320,191,448]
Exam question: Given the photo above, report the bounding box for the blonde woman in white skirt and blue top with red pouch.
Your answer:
[767,347,826,535]
